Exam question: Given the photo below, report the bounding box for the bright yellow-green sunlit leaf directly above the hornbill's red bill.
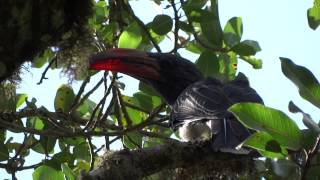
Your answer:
[118,23,142,49]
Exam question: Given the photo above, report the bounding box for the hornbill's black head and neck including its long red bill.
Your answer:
[90,49,203,105]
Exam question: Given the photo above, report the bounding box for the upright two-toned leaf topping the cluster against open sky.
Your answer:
[223,17,243,47]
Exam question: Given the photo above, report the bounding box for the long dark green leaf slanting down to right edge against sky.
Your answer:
[280,57,320,108]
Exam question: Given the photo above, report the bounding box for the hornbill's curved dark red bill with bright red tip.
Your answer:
[90,49,161,80]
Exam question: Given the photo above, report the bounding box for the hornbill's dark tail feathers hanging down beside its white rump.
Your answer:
[209,117,251,154]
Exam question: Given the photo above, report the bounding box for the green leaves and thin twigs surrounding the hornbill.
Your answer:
[0,0,320,179]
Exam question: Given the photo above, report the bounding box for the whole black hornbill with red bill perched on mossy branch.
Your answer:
[90,49,263,154]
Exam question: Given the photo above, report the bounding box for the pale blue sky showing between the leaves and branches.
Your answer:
[0,0,320,180]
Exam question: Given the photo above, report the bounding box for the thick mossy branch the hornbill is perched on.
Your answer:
[80,142,254,180]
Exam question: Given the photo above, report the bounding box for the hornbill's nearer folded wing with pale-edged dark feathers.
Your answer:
[171,80,230,130]
